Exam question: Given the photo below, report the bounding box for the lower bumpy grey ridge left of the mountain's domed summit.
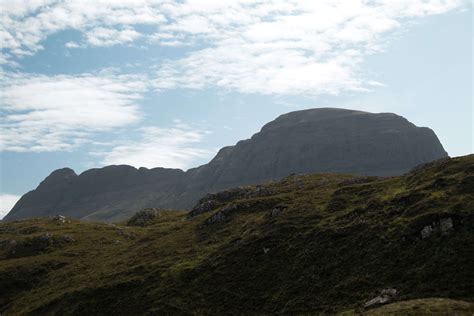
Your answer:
[5,165,185,221]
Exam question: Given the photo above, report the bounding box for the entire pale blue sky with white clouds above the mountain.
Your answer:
[0,0,474,218]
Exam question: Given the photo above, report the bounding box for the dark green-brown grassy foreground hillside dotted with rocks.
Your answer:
[0,155,474,315]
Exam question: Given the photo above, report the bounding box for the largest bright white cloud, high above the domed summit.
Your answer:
[154,0,465,95]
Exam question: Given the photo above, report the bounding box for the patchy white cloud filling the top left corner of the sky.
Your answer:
[0,0,165,61]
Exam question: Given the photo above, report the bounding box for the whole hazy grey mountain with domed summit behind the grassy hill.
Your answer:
[5,108,447,221]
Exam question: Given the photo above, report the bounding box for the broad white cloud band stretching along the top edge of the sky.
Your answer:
[0,0,470,94]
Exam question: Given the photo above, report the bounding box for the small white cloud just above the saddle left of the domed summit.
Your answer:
[94,122,213,169]
